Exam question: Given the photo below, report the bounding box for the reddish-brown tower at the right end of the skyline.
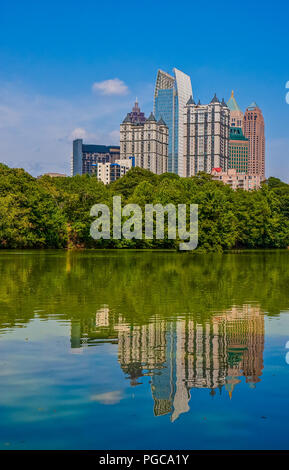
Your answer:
[243,102,265,181]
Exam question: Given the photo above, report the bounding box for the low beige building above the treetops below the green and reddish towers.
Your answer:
[212,168,262,191]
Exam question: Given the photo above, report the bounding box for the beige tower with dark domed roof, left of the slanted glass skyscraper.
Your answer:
[120,103,169,175]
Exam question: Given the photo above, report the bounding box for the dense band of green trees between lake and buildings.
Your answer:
[0,164,289,252]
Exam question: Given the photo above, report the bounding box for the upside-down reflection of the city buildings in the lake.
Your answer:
[71,304,265,421]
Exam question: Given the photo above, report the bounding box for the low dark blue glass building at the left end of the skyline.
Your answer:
[71,139,120,176]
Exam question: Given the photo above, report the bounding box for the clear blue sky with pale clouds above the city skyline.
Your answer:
[0,0,289,182]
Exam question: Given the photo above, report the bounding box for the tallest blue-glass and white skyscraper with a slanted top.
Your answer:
[154,68,193,176]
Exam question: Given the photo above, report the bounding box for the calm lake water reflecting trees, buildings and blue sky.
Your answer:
[0,250,289,449]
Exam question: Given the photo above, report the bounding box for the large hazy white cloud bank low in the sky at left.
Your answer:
[0,82,131,176]
